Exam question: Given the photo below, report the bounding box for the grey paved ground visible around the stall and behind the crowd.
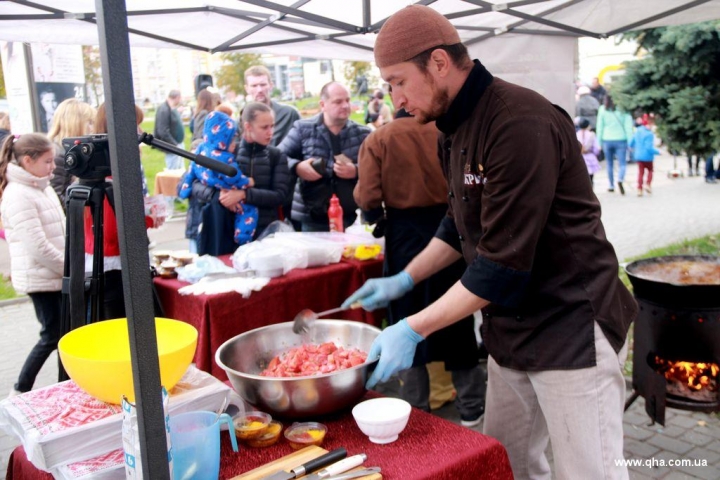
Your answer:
[0,150,720,480]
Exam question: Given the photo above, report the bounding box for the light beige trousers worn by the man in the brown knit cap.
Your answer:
[483,323,628,480]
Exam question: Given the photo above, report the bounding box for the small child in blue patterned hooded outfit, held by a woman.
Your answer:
[179,111,258,245]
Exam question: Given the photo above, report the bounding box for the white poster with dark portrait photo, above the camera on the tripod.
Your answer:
[30,43,85,132]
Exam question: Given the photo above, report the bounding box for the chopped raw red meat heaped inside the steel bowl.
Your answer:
[260,342,367,377]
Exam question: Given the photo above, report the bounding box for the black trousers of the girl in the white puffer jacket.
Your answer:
[14,292,62,392]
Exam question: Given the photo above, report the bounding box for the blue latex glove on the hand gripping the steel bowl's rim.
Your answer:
[365,318,425,389]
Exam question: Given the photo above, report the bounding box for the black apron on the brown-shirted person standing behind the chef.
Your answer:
[383,205,479,370]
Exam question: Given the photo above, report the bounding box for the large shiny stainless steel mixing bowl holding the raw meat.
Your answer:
[215,320,380,419]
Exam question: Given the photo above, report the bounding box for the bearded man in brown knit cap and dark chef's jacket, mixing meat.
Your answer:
[345,5,637,479]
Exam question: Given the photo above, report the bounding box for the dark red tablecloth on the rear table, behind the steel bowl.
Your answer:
[155,255,383,381]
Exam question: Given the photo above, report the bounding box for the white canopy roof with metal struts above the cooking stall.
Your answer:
[0,0,720,61]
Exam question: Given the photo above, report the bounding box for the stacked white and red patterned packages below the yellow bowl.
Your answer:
[0,365,244,478]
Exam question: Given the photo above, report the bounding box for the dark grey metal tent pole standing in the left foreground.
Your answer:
[95,0,170,480]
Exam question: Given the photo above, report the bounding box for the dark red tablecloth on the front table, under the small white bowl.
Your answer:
[6,392,513,480]
